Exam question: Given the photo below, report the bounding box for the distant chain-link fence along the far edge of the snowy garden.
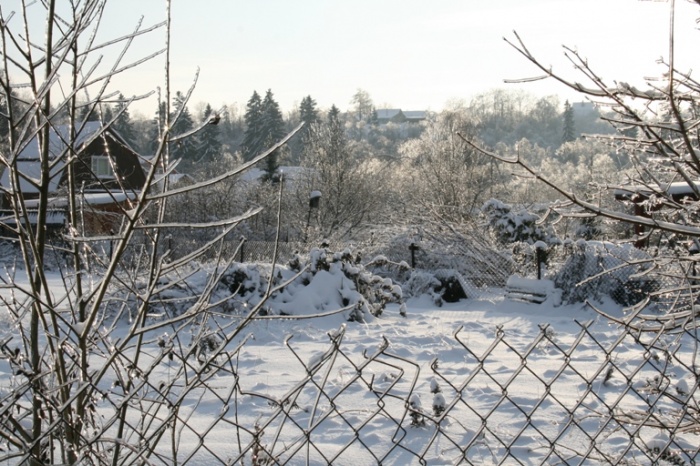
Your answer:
[154,237,684,308]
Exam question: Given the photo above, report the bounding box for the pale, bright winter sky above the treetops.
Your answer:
[2,0,698,115]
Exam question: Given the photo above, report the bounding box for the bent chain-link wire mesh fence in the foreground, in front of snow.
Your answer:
[0,306,700,465]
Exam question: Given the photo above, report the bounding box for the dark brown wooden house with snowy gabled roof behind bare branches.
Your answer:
[0,122,146,233]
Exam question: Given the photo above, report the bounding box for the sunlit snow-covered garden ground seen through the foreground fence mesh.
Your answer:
[0,268,698,466]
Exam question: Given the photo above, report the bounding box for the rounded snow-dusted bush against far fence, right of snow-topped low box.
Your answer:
[553,240,660,306]
